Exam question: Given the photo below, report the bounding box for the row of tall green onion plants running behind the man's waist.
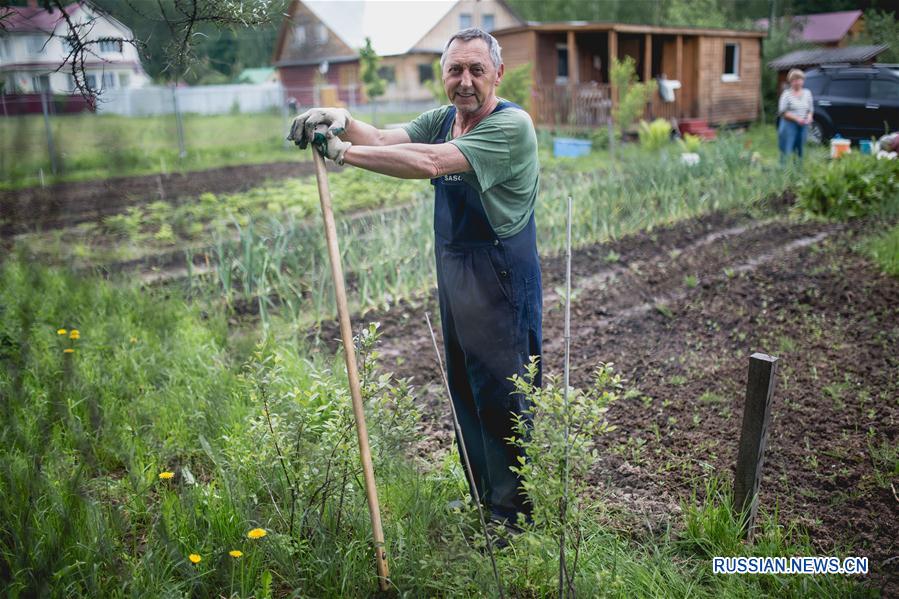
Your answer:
[206,136,789,324]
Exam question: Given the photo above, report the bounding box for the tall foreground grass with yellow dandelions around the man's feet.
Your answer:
[0,258,861,598]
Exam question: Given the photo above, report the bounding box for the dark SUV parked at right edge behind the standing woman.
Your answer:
[805,64,899,142]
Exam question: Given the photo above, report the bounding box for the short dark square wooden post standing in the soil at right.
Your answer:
[734,353,777,536]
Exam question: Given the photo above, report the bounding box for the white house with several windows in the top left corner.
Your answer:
[0,0,149,94]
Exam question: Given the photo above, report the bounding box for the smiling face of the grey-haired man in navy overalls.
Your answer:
[443,39,504,114]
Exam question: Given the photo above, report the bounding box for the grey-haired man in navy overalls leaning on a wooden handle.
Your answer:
[289,28,542,525]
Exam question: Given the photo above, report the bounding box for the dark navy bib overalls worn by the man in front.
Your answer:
[431,102,543,521]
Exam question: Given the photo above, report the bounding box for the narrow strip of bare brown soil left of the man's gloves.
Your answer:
[0,160,326,236]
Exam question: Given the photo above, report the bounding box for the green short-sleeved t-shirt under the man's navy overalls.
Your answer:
[404,100,540,238]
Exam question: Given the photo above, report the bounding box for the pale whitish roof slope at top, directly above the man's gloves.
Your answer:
[303,0,458,56]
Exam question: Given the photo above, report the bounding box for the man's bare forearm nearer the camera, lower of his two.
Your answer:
[344,144,440,179]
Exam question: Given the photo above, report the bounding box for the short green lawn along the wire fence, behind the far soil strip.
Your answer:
[0,112,428,189]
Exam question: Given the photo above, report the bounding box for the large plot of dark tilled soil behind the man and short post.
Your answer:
[324,214,899,591]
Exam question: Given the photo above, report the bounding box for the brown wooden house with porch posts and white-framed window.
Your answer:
[493,22,764,127]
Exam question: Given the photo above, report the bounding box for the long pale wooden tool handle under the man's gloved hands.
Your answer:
[312,147,390,591]
